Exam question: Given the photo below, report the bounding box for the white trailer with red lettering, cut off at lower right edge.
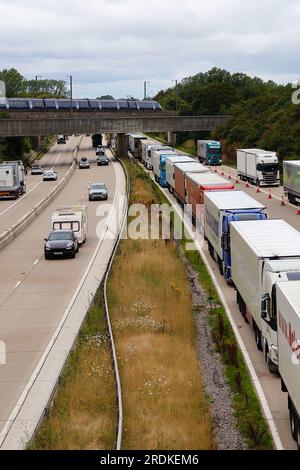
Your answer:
[276,281,300,450]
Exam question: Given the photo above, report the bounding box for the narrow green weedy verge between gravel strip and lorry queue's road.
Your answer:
[127,156,273,449]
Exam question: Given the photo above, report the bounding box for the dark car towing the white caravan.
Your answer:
[44,230,78,259]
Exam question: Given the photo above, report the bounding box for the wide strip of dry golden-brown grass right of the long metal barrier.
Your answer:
[108,163,214,449]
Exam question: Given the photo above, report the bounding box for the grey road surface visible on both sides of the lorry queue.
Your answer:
[139,157,300,450]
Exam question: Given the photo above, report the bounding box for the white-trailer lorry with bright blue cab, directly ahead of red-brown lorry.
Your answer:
[204,191,267,284]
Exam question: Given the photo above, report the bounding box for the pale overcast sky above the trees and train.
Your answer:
[0,0,300,98]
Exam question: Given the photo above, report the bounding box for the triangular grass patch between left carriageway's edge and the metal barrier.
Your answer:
[28,290,116,450]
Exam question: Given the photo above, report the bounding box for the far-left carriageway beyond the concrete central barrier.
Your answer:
[0,137,80,233]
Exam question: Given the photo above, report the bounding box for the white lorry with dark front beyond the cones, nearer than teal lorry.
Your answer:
[237,149,280,186]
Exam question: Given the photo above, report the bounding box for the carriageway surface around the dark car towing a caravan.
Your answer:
[0,137,123,444]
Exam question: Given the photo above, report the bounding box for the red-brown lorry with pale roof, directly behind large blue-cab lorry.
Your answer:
[186,172,234,223]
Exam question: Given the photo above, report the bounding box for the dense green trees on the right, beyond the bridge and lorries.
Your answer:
[155,68,300,164]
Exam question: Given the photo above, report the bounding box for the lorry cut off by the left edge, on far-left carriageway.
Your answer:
[0,160,26,199]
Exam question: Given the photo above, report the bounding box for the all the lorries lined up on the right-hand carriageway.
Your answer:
[129,135,300,449]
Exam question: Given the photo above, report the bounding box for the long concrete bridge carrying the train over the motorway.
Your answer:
[0,112,230,137]
